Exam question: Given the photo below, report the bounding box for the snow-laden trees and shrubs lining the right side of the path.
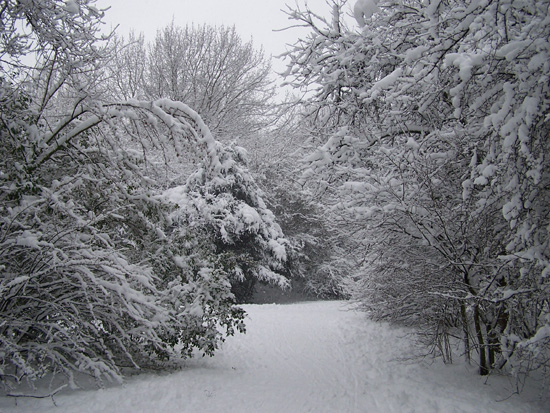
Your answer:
[288,0,550,380]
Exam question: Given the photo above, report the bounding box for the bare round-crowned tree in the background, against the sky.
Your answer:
[110,22,274,143]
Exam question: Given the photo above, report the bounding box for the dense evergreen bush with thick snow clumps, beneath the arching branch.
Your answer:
[165,110,288,302]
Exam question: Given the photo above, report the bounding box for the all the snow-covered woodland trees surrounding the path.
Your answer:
[0,0,550,391]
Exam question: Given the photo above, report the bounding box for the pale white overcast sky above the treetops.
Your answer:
[97,0,340,71]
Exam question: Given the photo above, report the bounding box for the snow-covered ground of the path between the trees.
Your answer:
[0,302,547,413]
